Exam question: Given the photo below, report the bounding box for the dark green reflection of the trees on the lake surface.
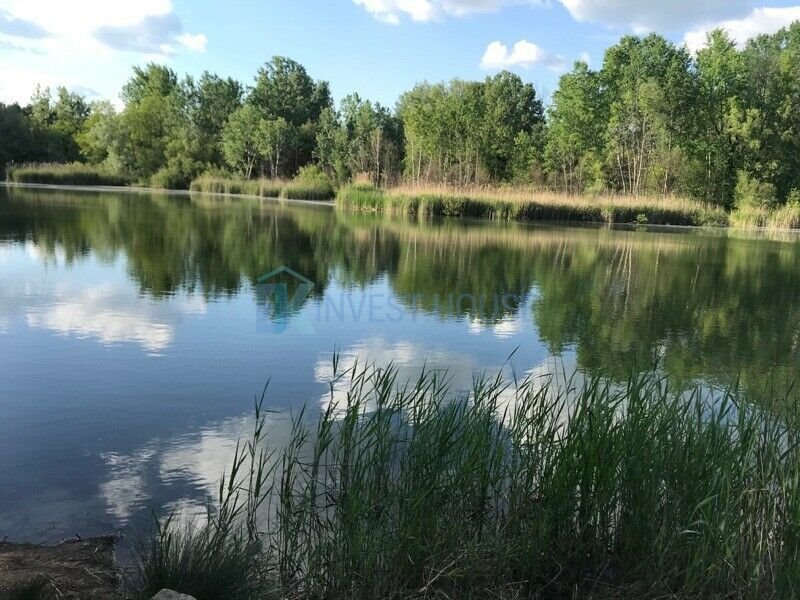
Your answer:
[6,190,800,392]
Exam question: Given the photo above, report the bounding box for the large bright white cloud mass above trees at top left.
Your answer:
[0,0,206,103]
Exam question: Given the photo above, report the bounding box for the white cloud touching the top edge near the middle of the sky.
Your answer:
[353,0,544,25]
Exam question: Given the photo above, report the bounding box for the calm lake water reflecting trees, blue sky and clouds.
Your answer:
[0,188,800,541]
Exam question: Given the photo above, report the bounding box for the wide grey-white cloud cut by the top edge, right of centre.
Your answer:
[559,0,753,33]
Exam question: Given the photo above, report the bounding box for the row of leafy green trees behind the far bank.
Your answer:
[0,22,800,209]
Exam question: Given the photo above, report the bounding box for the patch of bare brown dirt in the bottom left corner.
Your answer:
[0,537,120,600]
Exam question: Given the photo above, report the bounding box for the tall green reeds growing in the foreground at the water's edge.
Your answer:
[131,360,800,599]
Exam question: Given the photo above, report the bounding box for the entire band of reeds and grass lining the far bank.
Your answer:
[7,163,800,229]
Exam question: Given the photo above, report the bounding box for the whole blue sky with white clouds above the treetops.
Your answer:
[0,0,800,106]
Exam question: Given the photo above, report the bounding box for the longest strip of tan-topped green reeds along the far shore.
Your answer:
[337,185,728,226]
